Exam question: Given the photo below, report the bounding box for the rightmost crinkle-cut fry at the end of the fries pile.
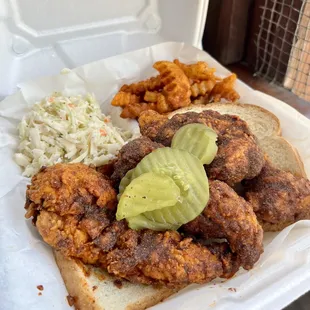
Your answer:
[210,73,240,102]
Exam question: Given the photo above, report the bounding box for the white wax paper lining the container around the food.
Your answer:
[0,42,310,310]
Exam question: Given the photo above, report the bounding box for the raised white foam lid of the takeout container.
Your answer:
[0,0,209,99]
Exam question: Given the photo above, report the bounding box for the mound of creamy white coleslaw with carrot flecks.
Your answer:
[15,93,132,177]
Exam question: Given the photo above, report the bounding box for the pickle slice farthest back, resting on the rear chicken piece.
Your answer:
[171,124,217,165]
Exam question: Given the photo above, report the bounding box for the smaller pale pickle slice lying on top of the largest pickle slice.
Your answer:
[116,172,180,220]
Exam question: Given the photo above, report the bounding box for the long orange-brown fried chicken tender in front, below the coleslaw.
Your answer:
[25,164,239,287]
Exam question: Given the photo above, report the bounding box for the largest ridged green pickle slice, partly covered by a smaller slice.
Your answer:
[117,147,209,230]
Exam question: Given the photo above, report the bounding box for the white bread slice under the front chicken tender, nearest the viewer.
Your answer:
[54,251,178,310]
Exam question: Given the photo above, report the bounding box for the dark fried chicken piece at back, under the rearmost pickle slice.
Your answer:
[139,110,265,185]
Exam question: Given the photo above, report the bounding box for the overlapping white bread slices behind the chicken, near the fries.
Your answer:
[169,103,307,177]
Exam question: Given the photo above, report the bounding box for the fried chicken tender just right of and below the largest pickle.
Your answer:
[183,181,263,269]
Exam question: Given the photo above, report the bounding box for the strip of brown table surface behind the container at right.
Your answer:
[228,64,310,119]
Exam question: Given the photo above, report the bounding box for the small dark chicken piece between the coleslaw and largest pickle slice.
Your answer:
[111,137,164,186]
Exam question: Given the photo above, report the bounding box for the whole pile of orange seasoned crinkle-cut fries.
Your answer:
[112,59,239,119]
